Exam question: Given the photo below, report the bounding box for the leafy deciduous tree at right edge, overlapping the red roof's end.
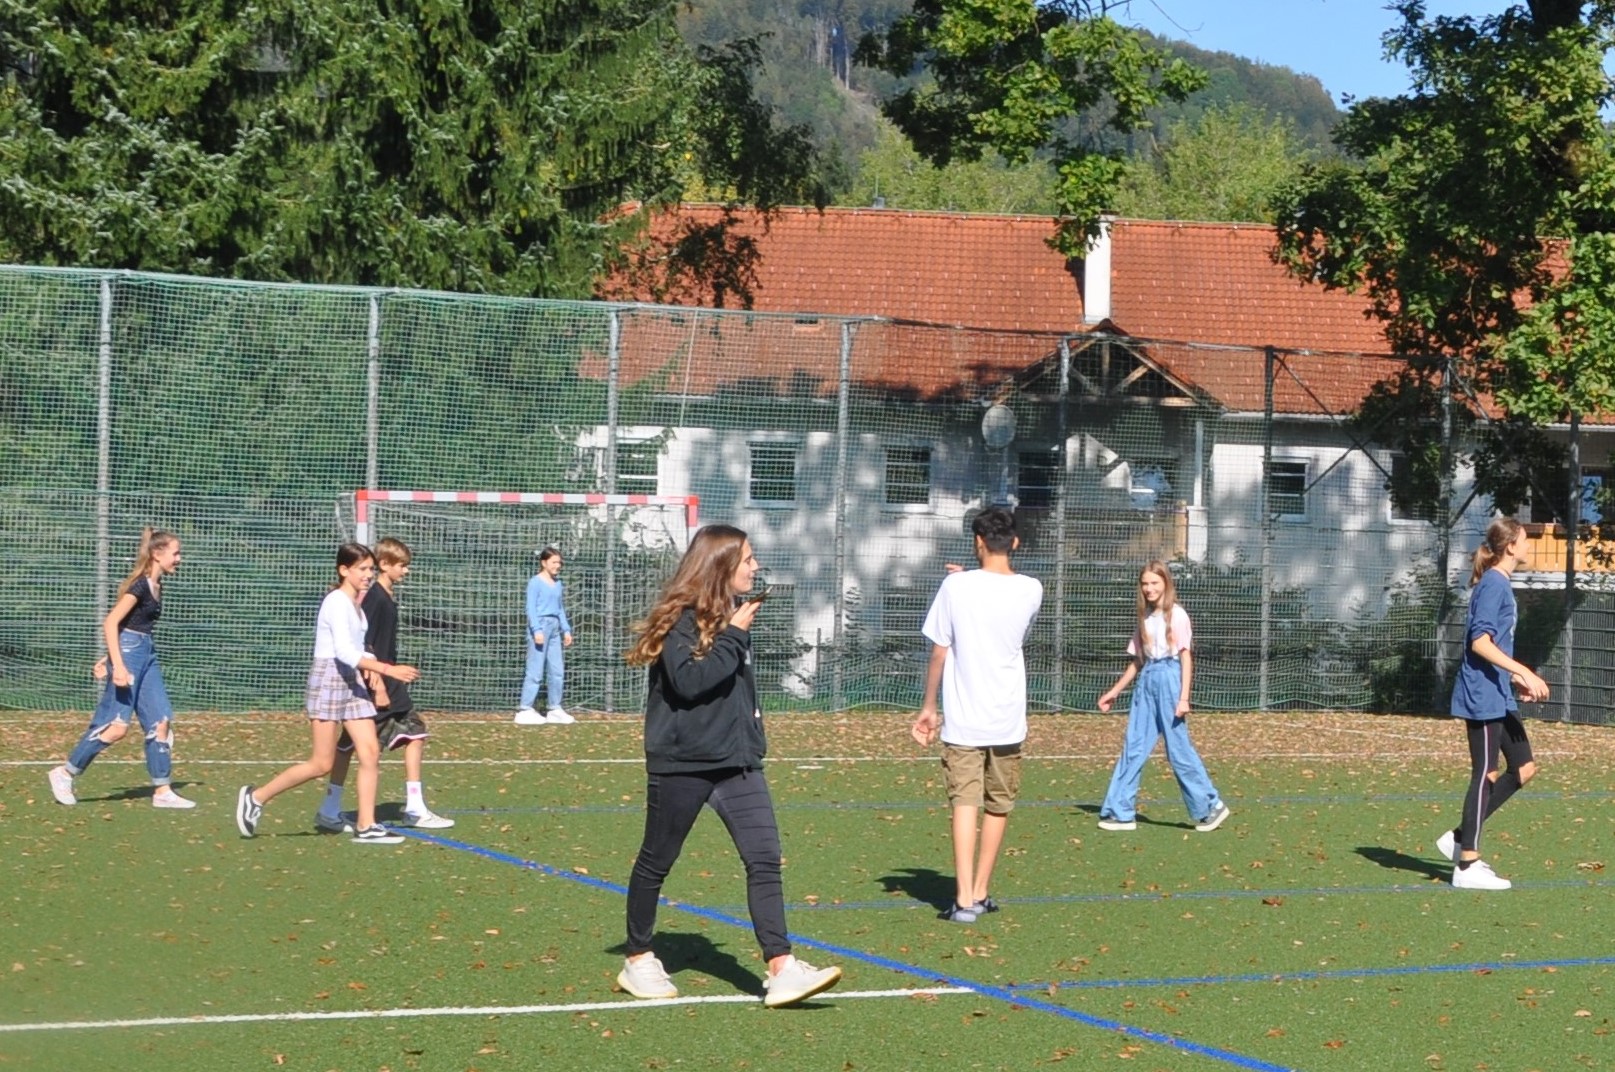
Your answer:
[1277,0,1615,512]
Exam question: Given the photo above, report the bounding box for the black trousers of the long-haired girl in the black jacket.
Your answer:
[628,767,791,961]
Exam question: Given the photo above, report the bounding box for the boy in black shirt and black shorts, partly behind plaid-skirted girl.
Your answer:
[313,536,454,833]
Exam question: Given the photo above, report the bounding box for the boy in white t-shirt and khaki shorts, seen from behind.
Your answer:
[909,507,1043,923]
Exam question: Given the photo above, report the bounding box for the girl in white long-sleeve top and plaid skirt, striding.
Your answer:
[236,544,420,844]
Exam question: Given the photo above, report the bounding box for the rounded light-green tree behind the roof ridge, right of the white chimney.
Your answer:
[1114,105,1310,223]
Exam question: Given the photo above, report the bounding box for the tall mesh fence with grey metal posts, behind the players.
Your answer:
[0,268,1615,720]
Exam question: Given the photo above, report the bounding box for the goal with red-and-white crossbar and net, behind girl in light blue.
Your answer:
[340,491,698,714]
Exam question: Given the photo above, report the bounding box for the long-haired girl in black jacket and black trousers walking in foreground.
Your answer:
[617,525,841,1007]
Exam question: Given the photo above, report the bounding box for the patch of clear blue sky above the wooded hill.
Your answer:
[1114,0,1508,103]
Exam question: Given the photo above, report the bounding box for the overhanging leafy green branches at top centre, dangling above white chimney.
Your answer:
[856,0,1205,255]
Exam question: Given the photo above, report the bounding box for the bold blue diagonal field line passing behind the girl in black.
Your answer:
[399,828,1297,1072]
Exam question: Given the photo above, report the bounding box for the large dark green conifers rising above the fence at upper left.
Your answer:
[0,0,826,297]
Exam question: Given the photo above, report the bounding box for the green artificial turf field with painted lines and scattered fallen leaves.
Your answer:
[0,714,1615,1072]
